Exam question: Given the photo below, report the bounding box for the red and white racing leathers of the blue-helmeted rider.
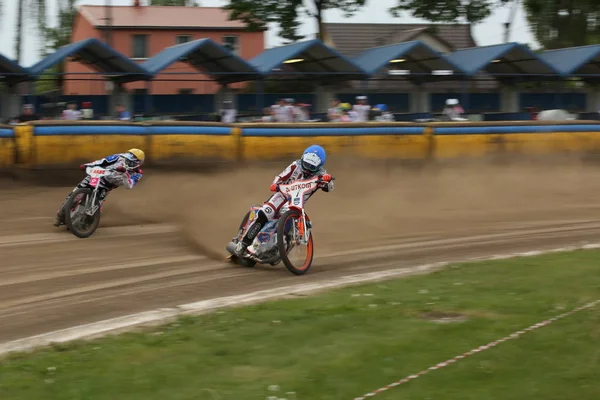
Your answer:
[235,160,334,256]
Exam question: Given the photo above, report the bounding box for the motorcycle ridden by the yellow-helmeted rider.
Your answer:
[64,167,117,239]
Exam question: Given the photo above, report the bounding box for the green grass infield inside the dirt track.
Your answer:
[0,251,600,400]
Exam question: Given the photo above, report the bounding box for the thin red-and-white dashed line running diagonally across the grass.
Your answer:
[354,300,600,400]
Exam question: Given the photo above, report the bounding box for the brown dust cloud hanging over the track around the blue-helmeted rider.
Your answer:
[94,160,600,259]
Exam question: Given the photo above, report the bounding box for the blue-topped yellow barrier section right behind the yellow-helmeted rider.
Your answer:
[29,121,239,166]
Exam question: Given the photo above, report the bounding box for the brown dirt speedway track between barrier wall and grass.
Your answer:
[0,161,600,342]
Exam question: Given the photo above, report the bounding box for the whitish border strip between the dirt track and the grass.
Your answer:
[0,243,600,355]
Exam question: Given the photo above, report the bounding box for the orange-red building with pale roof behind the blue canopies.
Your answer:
[64,5,265,95]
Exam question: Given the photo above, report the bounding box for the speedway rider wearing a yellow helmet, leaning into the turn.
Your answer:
[54,149,146,227]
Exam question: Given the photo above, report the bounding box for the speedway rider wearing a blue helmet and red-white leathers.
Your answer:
[235,145,334,257]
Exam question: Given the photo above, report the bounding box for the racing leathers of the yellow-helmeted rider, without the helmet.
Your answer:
[54,154,142,226]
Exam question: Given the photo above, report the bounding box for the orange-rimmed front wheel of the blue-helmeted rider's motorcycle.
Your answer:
[277,210,314,275]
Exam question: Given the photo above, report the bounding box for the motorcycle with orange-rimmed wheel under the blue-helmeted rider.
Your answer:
[226,176,335,275]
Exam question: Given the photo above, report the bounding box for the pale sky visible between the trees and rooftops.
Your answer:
[0,0,537,66]
